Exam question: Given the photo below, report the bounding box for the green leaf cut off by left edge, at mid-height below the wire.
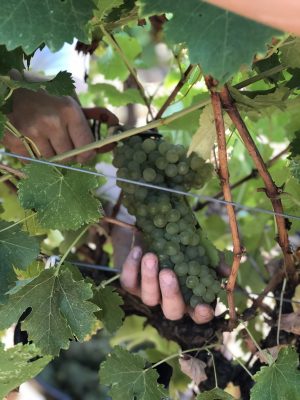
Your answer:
[0,221,39,301]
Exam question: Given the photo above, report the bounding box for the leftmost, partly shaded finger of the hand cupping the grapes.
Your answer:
[120,247,142,296]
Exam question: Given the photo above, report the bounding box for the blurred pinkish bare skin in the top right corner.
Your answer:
[206,0,300,35]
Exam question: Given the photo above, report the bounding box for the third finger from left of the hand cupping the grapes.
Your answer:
[159,269,186,320]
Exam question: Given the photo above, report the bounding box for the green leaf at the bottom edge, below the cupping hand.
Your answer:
[100,346,167,400]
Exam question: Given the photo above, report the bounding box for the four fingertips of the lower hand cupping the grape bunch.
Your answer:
[121,247,214,324]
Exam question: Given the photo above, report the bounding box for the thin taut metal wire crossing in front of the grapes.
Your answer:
[0,150,300,221]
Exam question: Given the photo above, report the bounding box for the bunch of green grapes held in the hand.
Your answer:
[113,136,220,307]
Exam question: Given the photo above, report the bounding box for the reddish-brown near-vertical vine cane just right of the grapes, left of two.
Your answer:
[205,77,244,329]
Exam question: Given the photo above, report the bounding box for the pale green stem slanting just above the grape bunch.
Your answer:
[48,96,210,161]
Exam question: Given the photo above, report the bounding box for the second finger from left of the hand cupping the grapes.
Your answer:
[141,253,160,306]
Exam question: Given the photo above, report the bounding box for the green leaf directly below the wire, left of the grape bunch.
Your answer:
[18,164,102,230]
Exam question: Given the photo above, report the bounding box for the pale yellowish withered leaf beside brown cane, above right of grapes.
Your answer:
[187,104,230,160]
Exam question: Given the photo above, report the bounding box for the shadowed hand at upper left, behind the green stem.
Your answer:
[3,89,118,163]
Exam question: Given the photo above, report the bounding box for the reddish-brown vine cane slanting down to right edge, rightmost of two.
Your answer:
[220,86,295,276]
